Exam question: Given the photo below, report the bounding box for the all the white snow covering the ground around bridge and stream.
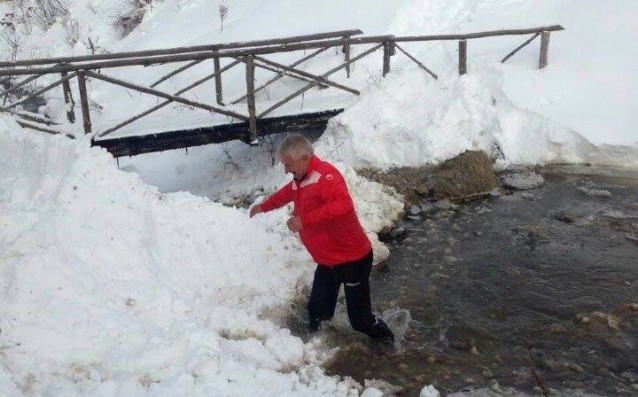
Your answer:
[0,0,638,397]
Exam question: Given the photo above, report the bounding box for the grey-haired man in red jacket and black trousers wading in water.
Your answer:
[250,134,394,343]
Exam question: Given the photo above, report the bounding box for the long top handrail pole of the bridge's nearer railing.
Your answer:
[0,35,393,76]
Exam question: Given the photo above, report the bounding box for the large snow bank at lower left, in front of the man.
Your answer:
[0,116,376,396]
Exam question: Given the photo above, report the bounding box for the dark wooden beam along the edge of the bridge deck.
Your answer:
[91,109,343,157]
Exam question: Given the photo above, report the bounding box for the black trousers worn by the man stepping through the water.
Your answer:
[308,250,394,341]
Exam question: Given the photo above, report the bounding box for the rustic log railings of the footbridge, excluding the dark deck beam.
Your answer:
[0,25,563,142]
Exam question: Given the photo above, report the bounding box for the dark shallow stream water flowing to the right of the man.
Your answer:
[298,167,638,396]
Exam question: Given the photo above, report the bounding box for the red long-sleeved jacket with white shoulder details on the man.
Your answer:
[261,156,372,266]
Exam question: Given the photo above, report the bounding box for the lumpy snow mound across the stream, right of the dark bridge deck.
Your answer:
[318,68,638,169]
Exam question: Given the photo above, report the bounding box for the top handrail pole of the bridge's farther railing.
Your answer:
[0,29,363,68]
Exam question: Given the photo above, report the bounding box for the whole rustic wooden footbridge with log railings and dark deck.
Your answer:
[0,25,563,157]
